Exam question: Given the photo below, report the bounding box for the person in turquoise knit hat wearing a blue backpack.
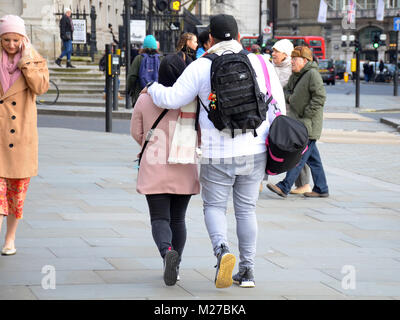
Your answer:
[126,35,161,105]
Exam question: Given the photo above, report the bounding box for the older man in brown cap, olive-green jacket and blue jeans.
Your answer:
[267,46,329,198]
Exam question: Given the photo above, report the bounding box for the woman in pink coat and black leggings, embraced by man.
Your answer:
[131,55,200,285]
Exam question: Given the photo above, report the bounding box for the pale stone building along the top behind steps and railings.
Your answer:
[0,0,268,60]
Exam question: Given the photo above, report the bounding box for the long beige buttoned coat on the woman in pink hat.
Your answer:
[0,47,49,179]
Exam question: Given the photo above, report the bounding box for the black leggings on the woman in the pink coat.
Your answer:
[146,193,191,258]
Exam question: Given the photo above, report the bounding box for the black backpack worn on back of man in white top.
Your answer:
[200,50,268,138]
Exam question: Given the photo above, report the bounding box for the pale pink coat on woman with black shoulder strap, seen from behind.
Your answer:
[131,94,200,194]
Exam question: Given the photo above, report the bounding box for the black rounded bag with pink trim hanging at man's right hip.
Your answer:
[265,115,308,175]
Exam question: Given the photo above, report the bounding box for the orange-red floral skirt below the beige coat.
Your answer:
[0,178,31,219]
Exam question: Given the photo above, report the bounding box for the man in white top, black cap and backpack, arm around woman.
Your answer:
[142,14,286,288]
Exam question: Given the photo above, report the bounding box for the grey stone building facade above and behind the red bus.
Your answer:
[275,0,400,62]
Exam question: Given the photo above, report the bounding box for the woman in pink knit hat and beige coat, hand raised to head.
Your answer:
[0,15,49,255]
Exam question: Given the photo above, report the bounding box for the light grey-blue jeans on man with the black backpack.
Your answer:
[200,153,267,269]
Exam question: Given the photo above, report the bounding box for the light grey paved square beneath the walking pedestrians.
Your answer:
[0,83,400,301]
